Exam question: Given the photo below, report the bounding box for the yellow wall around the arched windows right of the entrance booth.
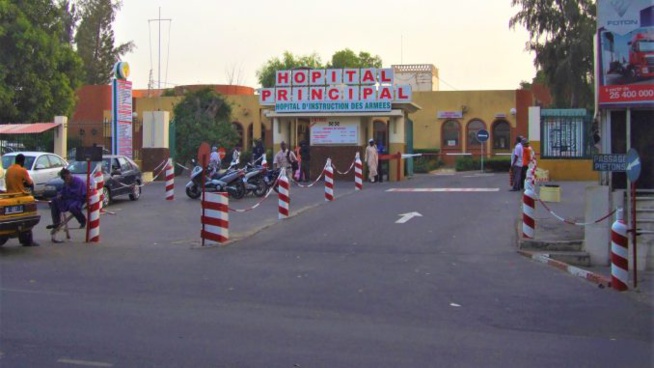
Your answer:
[409,90,516,150]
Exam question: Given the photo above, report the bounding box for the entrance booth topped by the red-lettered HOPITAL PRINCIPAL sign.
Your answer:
[259,68,420,181]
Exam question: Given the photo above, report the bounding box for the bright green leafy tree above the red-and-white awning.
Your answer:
[0,0,82,123]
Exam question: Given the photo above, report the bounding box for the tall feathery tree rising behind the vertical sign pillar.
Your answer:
[75,0,135,84]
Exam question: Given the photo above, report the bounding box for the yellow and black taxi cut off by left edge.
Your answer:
[0,193,41,246]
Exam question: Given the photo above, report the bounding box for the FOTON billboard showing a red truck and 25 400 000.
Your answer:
[597,0,654,108]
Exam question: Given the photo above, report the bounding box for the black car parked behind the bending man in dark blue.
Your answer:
[43,155,143,206]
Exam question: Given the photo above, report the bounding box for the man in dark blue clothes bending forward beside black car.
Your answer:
[46,169,86,229]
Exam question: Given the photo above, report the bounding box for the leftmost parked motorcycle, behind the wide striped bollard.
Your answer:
[186,160,246,199]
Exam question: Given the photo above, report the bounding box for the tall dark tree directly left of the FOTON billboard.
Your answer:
[509,0,596,108]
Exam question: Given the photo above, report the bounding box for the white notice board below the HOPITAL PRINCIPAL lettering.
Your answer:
[311,118,359,146]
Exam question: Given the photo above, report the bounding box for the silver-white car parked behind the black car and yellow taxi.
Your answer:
[2,151,68,197]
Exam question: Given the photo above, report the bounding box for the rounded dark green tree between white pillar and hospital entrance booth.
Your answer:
[174,88,239,162]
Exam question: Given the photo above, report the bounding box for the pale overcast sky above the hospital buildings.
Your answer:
[114,0,535,90]
